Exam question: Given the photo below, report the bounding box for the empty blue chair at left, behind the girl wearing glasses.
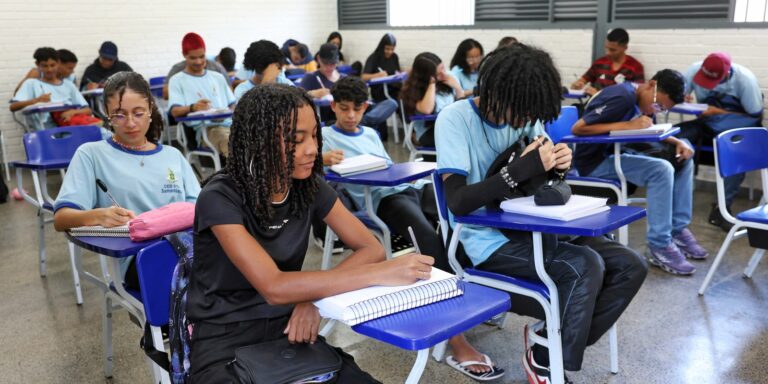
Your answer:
[11,125,102,304]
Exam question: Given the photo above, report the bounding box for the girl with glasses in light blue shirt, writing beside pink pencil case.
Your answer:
[53,72,200,290]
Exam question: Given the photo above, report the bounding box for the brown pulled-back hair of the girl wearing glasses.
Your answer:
[103,71,163,143]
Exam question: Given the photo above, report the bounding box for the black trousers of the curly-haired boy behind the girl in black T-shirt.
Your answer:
[376,184,451,272]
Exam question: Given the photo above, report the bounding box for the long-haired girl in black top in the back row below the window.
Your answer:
[360,33,401,103]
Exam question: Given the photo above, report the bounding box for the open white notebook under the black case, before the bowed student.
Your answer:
[501,195,609,221]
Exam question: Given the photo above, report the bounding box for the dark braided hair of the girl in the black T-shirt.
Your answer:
[213,84,323,225]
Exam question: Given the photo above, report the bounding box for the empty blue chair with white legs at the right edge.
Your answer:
[699,127,768,295]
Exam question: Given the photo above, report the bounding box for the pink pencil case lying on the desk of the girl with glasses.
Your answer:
[128,202,195,241]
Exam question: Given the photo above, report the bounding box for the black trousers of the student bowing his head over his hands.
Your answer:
[477,236,648,371]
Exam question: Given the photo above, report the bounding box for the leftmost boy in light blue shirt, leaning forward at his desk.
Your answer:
[10,47,102,128]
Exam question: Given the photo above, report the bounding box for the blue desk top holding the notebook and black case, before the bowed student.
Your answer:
[454,205,645,236]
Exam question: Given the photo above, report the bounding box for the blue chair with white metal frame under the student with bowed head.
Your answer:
[432,172,632,384]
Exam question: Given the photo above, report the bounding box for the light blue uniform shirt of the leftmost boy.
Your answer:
[11,79,88,128]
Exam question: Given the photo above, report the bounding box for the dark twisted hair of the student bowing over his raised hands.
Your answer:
[477,44,562,127]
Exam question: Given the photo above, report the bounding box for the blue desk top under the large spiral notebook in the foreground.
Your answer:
[352,283,511,351]
